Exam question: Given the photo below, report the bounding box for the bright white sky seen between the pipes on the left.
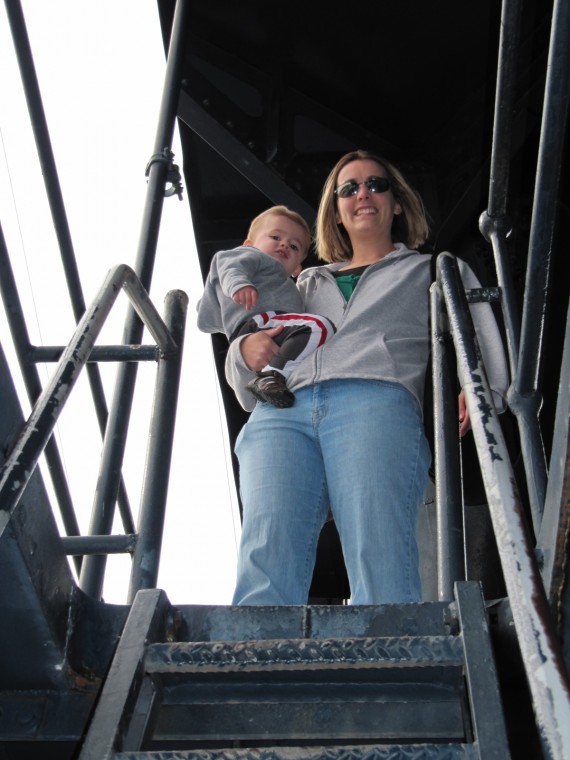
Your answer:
[0,0,240,604]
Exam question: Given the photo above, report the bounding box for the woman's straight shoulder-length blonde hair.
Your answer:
[315,150,429,263]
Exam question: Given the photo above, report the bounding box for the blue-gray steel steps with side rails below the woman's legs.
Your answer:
[79,582,510,760]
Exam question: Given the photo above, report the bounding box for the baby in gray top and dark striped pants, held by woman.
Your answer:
[197,206,334,408]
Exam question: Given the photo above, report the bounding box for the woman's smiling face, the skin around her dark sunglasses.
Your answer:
[336,159,402,239]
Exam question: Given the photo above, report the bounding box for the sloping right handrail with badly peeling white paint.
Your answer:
[437,253,570,760]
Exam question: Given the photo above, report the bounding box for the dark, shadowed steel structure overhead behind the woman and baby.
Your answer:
[159,0,568,460]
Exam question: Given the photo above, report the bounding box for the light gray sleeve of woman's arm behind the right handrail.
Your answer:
[458,259,509,413]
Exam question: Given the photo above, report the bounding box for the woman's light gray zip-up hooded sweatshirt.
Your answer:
[222,243,508,412]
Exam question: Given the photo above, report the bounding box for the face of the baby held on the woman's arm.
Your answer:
[251,214,311,277]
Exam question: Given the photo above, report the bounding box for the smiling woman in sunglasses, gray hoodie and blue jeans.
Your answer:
[226,151,507,604]
